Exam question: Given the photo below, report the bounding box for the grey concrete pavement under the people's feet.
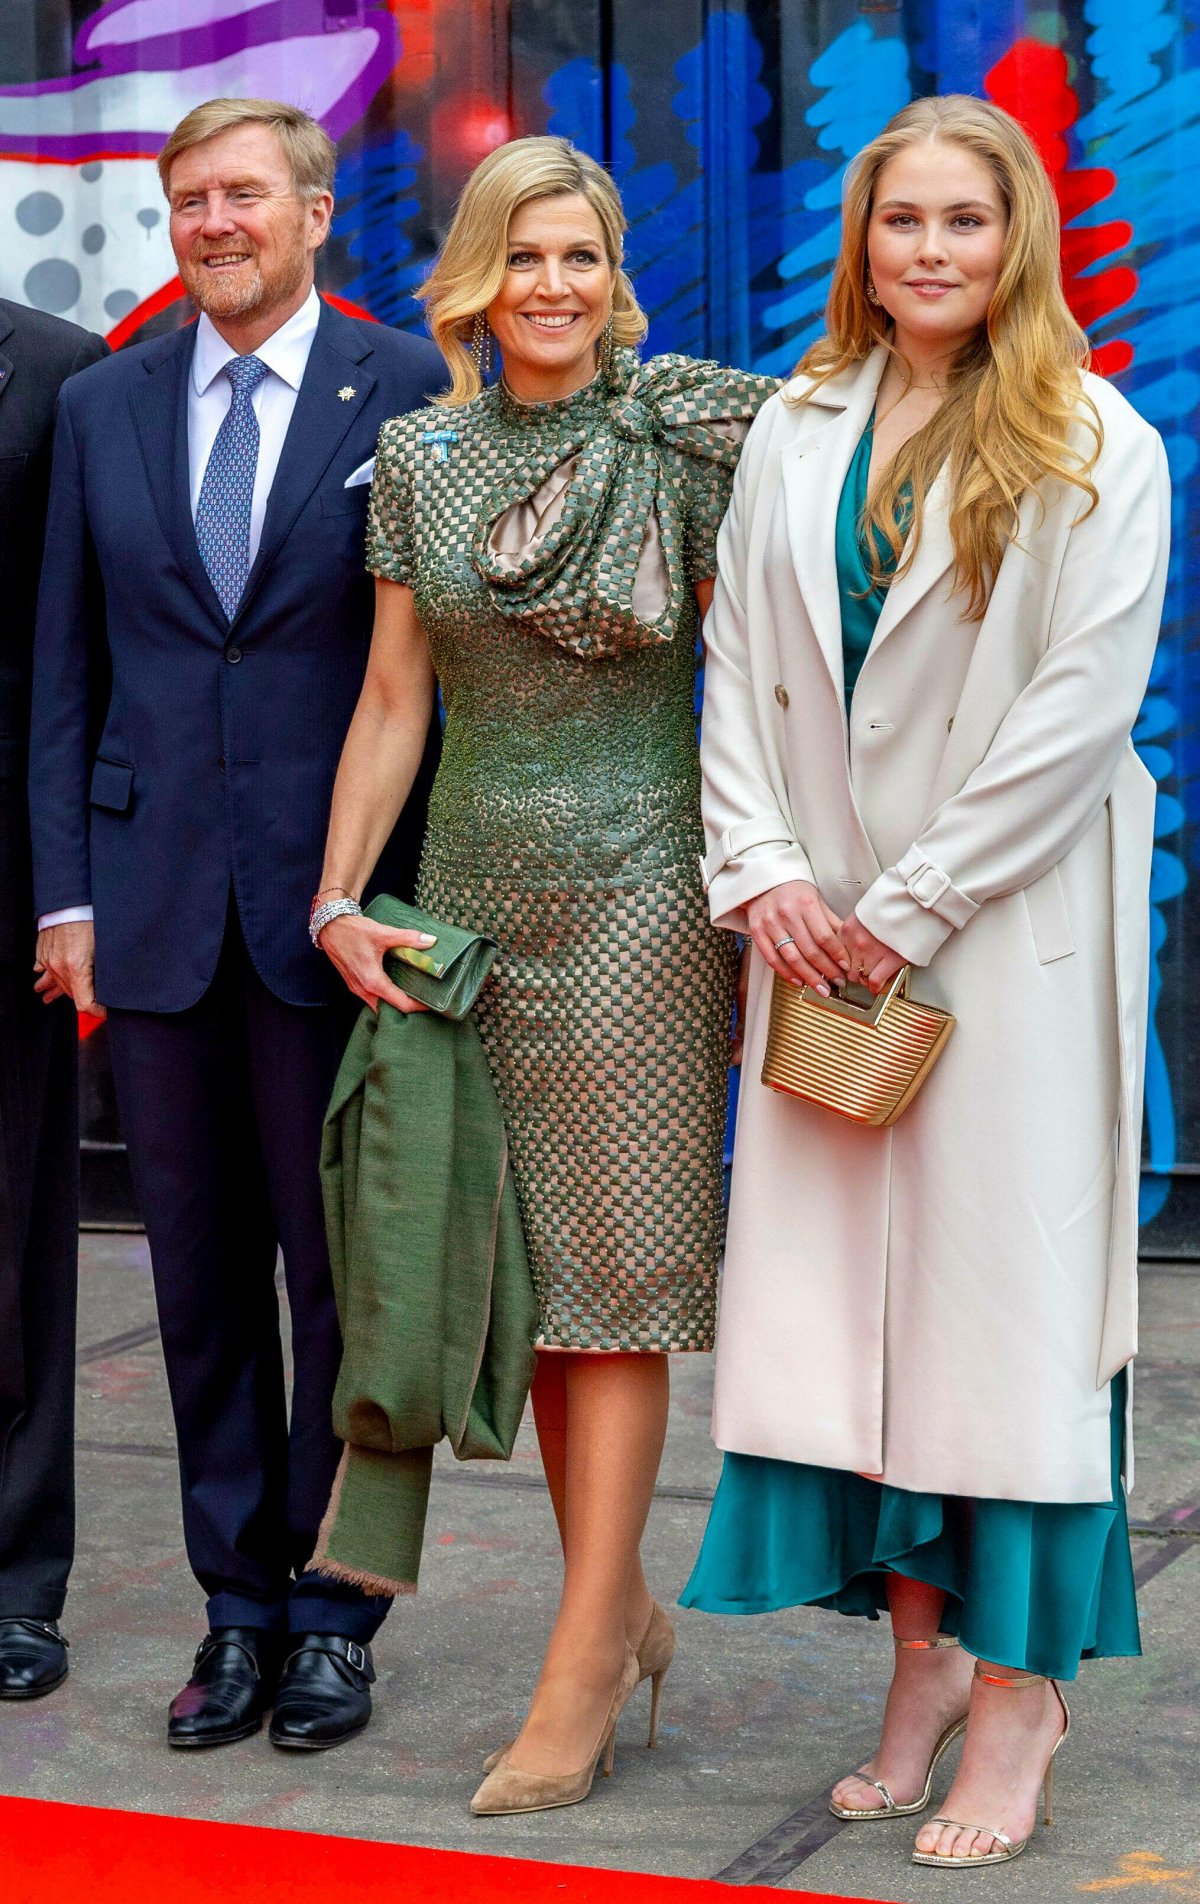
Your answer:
[0,1234,1200,1904]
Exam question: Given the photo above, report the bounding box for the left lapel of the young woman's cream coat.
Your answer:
[779,345,888,703]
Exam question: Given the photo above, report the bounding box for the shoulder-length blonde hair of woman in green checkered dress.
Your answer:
[417,137,648,406]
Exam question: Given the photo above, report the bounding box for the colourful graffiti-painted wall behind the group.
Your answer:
[0,0,1200,1251]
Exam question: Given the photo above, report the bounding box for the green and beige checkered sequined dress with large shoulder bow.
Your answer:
[368,350,775,1350]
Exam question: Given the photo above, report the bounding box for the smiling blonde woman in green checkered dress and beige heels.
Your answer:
[320,139,773,1813]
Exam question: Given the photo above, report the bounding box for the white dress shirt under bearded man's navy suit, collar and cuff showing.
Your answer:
[38,289,320,927]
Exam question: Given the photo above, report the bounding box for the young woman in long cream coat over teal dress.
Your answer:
[684,97,1170,1864]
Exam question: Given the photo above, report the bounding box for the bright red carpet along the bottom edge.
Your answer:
[0,1797,887,1904]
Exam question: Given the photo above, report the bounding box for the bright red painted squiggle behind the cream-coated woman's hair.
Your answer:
[983,40,1137,377]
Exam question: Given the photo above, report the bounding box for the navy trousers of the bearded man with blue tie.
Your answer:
[109,902,389,1641]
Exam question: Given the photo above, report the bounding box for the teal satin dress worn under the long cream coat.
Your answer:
[680,419,1141,1679]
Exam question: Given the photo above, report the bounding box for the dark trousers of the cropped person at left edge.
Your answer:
[0,974,80,1620]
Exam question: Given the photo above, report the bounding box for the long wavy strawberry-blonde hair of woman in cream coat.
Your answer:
[803,93,1103,621]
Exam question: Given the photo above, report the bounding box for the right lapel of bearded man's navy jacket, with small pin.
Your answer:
[234,301,375,621]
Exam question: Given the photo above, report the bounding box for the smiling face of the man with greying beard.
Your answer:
[168,126,333,318]
